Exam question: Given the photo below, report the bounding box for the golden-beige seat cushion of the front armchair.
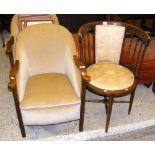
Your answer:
[20,73,80,110]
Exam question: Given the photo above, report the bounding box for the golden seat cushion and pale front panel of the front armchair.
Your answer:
[20,73,80,125]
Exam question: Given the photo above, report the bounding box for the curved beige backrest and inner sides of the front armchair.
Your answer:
[16,23,81,99]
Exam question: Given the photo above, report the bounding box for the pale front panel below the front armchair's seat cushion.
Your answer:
[21,104,80,125]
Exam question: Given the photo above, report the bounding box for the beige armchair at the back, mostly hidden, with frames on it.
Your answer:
[6,14,59,66]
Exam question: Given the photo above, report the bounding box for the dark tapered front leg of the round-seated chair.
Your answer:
[105,96,113,133]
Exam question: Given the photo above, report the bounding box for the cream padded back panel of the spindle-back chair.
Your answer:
[95,25,125,63]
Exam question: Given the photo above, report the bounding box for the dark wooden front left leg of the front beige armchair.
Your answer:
[13,88,26,137]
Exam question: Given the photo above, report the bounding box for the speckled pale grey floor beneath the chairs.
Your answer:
[0,33,155,140]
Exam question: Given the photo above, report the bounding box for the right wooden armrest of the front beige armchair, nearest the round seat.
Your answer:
[73,55,90,82]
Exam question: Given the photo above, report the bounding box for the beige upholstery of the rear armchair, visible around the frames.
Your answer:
[10,14,59,61]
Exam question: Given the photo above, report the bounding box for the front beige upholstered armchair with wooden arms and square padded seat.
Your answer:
[9,23,89,137]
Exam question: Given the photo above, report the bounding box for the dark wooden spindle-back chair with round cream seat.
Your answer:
[79,21,150,132]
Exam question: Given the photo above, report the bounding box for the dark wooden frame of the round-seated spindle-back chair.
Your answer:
[78,21,150,133]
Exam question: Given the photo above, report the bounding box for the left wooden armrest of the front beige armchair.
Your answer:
[8,60,19,89]
